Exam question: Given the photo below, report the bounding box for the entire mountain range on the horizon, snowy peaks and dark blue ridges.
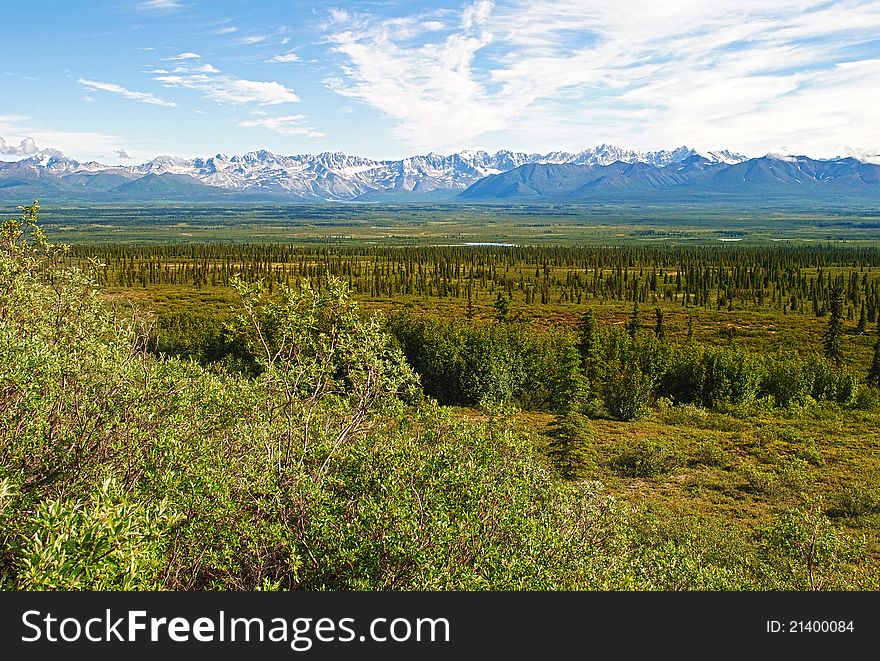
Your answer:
[0,145,880,203]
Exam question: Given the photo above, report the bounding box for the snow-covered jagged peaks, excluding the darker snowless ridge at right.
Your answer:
[0,144,869,201]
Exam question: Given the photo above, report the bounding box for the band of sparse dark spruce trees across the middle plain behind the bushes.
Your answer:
[68,244,880,323]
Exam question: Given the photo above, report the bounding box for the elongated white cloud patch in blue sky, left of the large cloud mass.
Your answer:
[154,64,299,106]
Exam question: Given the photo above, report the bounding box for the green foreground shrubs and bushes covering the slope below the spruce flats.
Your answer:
[0,205,880,590]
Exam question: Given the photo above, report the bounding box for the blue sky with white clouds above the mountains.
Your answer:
[0,0,880,164]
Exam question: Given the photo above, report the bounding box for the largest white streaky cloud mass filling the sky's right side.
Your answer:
[326,0,880,154]
